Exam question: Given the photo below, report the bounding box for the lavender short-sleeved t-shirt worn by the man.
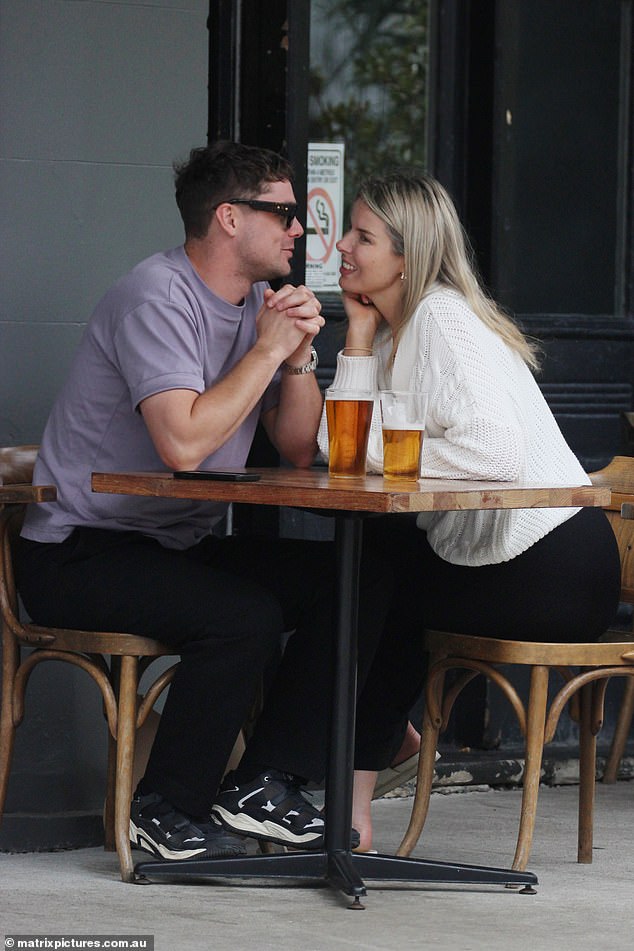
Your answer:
[22,247,279,548]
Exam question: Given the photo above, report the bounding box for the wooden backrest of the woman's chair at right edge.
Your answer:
[590,456,634,604]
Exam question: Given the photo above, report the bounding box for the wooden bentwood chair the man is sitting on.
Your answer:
[0,446,177,882]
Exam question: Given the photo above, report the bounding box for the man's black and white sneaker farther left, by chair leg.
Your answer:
[130,793,247,860]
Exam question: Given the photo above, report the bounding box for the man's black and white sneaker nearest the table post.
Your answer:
[212,769,359,849]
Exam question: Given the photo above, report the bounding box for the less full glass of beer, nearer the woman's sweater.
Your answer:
[379,390,427,480]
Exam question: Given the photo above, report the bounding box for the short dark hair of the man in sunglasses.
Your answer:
[174,142,293,238]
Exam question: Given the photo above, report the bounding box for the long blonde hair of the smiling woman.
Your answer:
[356,170,539,370]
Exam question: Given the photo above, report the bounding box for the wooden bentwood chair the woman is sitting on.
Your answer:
[398,456,634,871]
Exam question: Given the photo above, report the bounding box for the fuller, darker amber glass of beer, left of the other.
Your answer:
[326,387,374,479]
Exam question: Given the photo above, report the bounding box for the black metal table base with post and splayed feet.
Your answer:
[135,511,537,908]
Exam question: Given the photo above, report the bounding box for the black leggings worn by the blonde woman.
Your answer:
[355,508,620,769]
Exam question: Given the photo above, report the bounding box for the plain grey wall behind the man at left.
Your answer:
[0,0,209,848]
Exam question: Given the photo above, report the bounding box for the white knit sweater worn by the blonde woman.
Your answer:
[319,285,590,566]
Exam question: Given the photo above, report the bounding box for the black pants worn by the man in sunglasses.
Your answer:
[16,528,393,815]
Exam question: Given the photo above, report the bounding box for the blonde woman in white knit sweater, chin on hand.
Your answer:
[320,171,620,849]
